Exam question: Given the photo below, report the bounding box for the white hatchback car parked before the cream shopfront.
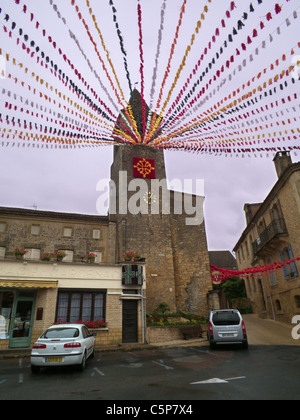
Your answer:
[30,324,96,373]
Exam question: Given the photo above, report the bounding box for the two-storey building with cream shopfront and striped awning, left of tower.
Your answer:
[0,208,146,348]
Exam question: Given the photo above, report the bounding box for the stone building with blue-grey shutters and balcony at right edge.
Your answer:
[234,152,300,323]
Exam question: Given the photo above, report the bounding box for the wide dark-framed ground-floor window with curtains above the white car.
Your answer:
[56,291,105,322]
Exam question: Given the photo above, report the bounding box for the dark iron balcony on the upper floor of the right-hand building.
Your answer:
[252,219,288,256]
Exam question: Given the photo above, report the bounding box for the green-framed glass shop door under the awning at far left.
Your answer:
[9,291,35,348]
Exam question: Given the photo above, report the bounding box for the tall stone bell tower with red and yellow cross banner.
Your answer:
[109,90,212,316]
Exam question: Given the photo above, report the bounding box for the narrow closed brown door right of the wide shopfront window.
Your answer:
[122,299,138,343]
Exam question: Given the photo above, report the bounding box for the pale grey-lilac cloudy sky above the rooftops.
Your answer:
[0,0,300,250]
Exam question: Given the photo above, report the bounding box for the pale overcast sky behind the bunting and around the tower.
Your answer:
[0,0,300,251]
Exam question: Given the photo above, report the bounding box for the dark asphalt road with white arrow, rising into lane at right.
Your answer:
[0,315,300,400]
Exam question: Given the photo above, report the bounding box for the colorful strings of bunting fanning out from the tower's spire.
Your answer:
[0,0,300,157]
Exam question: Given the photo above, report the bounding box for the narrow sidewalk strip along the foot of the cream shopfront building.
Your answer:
[0,338,209,360]
